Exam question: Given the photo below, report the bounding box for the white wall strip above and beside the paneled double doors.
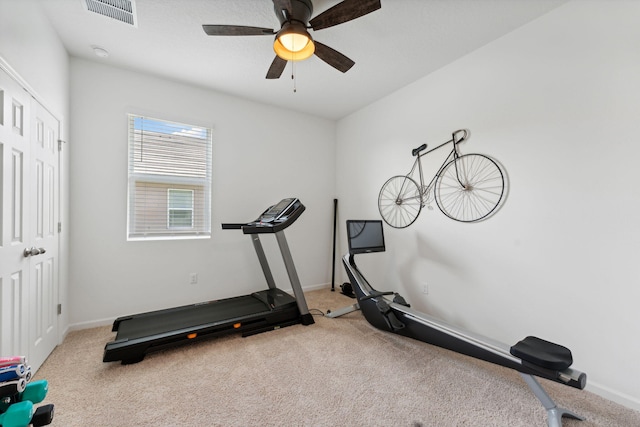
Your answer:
[0,0,69,342]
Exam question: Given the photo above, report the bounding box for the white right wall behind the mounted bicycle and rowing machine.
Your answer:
[337,1,640,409]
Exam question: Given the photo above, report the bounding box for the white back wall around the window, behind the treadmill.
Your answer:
[70,58,335,326]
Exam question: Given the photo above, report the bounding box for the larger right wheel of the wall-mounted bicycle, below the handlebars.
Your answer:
[434,154,504,222]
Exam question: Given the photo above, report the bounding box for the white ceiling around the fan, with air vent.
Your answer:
[39,0,567,119]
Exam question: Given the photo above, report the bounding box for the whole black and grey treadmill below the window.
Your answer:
[102,198,315,365]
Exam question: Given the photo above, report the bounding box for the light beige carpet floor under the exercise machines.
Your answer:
[36,289,640,427]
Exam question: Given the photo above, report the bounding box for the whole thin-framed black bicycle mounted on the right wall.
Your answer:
[378,129,504,228]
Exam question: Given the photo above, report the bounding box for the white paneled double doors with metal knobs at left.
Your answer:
[0,70,59,370]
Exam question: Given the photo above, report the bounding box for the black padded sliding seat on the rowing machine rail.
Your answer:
[510,336,573,371]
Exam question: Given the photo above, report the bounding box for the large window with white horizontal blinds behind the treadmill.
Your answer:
[127,115,212,240]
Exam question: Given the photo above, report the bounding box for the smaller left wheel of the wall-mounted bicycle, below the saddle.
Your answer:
[378,175,422,228]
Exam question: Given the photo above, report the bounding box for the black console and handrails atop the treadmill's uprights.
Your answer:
[222,197,305,234]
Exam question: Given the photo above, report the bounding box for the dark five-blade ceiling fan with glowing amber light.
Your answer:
[202,0,382,79]
